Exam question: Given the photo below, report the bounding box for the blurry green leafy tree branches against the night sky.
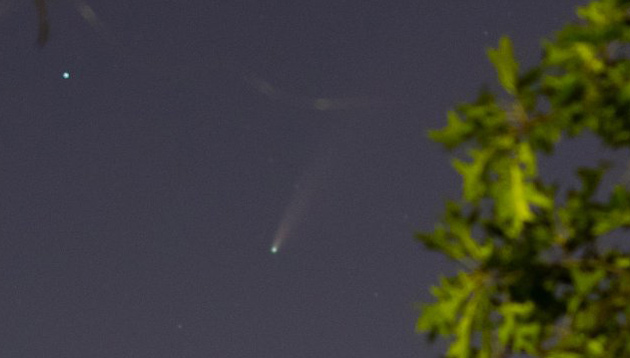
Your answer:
[417,0,630,358]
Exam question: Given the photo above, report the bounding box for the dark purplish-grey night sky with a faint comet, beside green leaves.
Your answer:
[0,0,616,358]
